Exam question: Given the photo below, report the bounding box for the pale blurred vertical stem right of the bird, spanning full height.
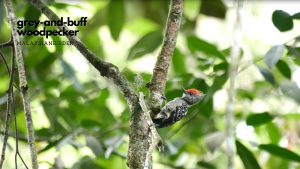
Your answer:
[226,0,243,169]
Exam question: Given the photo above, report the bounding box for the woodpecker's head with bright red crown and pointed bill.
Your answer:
[181,87,205,106]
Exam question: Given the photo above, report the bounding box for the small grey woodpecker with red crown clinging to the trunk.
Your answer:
[153,87,205,128]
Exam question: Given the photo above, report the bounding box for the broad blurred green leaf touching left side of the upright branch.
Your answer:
[128,29,163,60]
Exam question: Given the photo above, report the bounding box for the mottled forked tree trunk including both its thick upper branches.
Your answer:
[29,0,183,169]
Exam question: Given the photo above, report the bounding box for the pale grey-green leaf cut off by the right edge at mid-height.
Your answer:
[279,82,300,103]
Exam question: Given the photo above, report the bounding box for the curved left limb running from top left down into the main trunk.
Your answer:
[29,0,149,168]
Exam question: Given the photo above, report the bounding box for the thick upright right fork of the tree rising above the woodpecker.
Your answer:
[147,0,184,117]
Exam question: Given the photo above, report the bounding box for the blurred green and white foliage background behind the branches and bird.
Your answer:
[0,0,300,169]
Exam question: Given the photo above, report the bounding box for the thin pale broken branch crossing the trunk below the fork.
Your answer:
[139,92,164,169]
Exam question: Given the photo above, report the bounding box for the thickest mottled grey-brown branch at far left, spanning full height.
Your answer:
[5,0,39,169]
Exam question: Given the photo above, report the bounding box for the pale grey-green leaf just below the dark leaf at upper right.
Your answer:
[264,45,285,68]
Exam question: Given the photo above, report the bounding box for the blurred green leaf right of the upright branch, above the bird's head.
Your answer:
[187,36,225,61]
